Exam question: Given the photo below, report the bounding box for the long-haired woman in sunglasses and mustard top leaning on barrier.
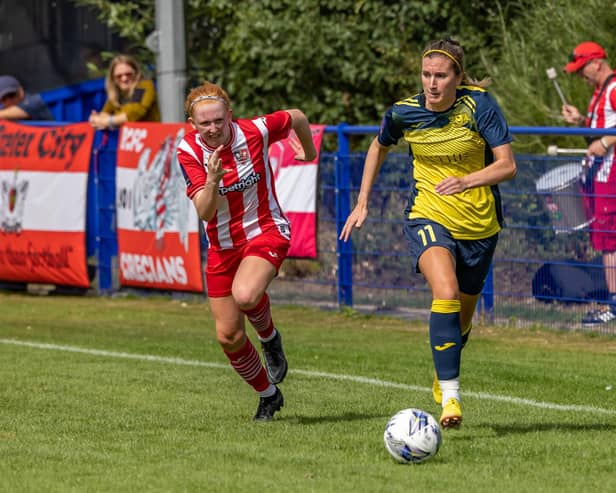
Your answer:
[89,55,160,130]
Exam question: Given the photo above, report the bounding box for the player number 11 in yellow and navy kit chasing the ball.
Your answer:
[340,39,516,428]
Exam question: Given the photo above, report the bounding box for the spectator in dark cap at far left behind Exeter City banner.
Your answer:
[0,75,54,120]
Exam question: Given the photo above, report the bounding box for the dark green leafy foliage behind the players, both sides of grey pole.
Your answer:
[75,0,517,125]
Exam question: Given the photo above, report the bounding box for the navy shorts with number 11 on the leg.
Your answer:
[404,219,498,295]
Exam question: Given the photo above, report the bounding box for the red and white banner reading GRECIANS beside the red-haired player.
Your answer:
[116,122,204,292]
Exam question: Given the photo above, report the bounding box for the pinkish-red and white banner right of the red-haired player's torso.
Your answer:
[269,125,325,258]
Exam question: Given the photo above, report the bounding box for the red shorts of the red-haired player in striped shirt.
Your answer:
[205,228,290,298]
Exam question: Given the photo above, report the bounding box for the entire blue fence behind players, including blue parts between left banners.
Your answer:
[24,80,616,326]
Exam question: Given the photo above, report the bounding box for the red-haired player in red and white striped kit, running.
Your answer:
[178,82,317,421]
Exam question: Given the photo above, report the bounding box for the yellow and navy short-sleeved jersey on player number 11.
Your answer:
[378,86,512,240]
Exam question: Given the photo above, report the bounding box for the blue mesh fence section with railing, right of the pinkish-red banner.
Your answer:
[281,125,616,330]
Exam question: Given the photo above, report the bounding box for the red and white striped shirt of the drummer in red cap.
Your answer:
[586,77,616,214]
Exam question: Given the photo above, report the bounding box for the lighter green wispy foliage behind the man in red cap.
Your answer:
[490,0,616,151]
